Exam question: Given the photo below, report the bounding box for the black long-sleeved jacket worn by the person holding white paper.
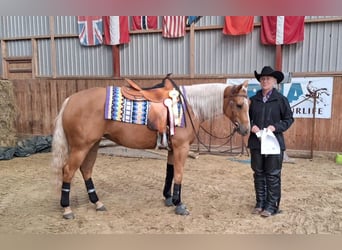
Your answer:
[248,88,294,150]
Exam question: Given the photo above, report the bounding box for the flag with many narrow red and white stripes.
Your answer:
[162,16,186,38]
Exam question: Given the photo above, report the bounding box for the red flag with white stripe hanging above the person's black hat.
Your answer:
[261,16,305,45]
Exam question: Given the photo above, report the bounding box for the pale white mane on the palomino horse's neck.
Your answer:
[183,83,230,120]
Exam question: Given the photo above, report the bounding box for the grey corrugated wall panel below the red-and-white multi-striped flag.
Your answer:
[120,33,190,76]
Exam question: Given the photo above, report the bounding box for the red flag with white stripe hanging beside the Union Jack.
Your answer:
[103,16,130,45]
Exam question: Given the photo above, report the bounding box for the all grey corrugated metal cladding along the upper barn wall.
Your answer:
[0,16,342,77]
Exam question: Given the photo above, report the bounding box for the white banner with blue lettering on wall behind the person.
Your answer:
[226,77,333,119]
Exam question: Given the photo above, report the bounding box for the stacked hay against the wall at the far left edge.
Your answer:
[0,80,17,147]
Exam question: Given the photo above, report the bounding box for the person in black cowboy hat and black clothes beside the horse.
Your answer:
[248,66,294,217]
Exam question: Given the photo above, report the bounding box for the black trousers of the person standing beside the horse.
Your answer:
[251,150,284,214]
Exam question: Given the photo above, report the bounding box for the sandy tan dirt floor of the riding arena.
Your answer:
[0,146,342,234]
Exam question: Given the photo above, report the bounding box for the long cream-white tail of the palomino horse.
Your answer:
[51,98,69,192]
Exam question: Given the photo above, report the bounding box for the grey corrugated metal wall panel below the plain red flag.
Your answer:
[195,30,275,75]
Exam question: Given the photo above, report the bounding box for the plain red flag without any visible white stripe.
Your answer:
[222,16,254,36]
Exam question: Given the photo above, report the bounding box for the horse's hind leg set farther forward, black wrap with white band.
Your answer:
[80,141,106,211]
